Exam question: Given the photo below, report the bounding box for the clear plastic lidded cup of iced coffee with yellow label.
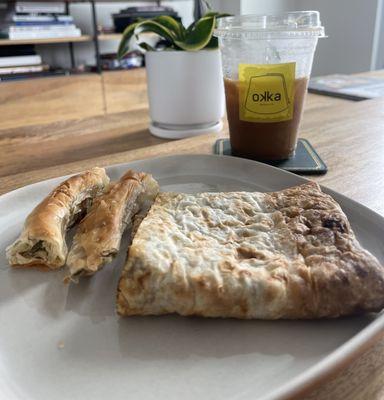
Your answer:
[215,11,324,160]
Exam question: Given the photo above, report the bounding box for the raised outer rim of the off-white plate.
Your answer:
[0,154,384,400]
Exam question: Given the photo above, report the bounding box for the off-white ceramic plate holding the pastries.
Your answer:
[0,155,384,400]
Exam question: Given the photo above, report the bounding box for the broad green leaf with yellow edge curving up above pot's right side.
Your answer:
[174,17,216,51]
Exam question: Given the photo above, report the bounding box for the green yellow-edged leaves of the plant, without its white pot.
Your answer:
[117,11,229,58]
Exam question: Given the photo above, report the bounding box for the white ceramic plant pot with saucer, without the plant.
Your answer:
[145,50,225,139]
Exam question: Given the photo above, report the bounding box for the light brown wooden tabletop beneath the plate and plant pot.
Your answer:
[0,72,384,400]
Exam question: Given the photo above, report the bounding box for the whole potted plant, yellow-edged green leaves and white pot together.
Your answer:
[118,11,226,139]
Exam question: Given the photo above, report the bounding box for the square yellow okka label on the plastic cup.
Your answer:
[239,63,296,122]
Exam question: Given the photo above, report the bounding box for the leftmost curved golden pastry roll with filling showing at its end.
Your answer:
[6,167,109,269]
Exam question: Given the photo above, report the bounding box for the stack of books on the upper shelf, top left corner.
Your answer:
[8,1,81,40]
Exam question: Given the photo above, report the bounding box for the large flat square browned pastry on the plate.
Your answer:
[117,183,384,319]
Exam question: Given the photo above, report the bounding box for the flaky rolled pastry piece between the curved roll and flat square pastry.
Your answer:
[67,170,159,278]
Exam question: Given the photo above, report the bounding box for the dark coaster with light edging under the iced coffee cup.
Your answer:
[214,139,328,175]
